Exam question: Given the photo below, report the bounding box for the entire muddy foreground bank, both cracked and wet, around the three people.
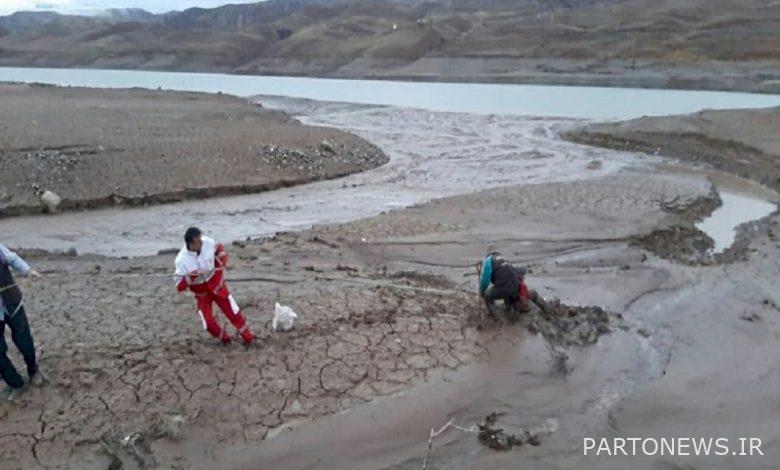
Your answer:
[6,161,780,469]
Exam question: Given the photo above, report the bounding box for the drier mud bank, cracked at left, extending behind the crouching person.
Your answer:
[0,170,710,468]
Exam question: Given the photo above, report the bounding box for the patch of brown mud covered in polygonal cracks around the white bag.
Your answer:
[0,262,481,468]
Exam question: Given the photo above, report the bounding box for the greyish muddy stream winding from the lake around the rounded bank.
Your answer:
[3,97,657,256]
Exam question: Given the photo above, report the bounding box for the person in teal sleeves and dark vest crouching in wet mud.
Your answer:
[477,251,548,315]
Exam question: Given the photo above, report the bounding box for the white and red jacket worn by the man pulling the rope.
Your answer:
[174,236,228,295]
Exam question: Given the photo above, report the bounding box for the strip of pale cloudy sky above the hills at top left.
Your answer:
[0,0,258,15]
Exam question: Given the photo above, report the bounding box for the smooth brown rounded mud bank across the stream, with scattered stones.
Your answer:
[0,84,387,215]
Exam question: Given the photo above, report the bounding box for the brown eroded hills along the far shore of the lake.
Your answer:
[0,0,780,93]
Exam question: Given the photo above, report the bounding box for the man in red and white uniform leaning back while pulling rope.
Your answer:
[175,227,255,346]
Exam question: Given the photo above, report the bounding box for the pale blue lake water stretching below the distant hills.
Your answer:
[0,68,780,120]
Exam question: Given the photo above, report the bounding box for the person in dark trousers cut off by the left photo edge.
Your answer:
[0,245,45,402]
